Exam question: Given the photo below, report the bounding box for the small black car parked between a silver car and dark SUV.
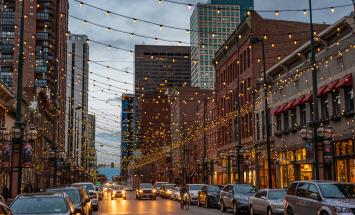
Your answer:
[197,185,221,208]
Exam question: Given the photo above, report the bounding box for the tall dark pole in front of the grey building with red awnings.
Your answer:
[309,0,319,180]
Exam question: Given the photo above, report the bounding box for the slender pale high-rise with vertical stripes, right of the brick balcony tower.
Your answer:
[65,34,90,170]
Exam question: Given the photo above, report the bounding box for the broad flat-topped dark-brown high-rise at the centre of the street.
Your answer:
[134,45,191,180]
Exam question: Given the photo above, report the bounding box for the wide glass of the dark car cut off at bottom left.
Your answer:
[11,197,68,214]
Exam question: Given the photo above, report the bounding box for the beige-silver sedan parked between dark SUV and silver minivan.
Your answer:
[249,189,286,215]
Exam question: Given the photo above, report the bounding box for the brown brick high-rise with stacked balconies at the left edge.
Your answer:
[0,0,68,187]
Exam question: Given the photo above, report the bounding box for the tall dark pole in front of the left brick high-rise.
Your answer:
[10,0,25,197]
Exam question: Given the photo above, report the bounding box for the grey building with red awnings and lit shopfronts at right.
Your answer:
[255,17,355,187]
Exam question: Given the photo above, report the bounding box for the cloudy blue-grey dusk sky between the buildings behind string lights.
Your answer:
[69,0,353,163]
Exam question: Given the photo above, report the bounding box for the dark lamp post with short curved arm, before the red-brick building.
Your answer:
[250,37,272,188]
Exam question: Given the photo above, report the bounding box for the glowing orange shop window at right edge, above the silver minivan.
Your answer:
[334,139,355,183]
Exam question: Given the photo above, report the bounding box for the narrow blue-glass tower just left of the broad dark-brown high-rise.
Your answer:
[121,94,134,179]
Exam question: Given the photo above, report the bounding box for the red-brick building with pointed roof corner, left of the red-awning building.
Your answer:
[215,12,326,186]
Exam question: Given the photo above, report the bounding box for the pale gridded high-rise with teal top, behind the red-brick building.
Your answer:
[190,0,254,89]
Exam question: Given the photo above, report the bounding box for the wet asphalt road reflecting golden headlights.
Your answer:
[94,192,235,215]
